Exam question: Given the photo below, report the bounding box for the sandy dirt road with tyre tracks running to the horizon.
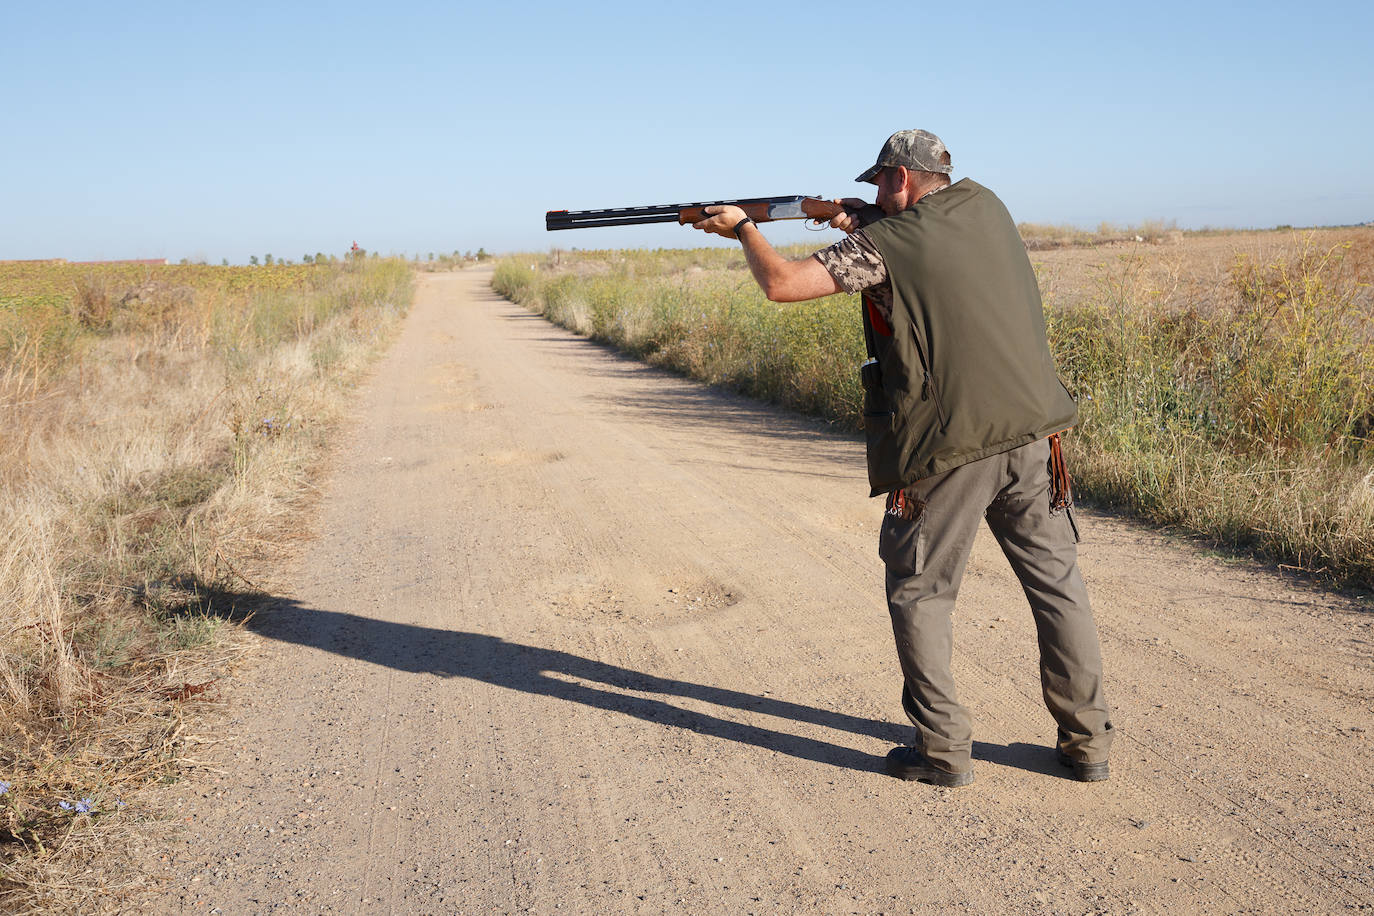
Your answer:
[144,271,1374,913]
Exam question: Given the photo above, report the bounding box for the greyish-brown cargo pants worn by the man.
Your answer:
[878,439,1113,773]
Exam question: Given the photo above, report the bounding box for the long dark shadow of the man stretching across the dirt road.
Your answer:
[202,591,1058,775]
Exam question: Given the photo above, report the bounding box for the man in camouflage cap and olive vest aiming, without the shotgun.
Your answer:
[694,130,1113,787]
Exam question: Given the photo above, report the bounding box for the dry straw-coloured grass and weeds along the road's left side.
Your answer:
[0,258,412,912]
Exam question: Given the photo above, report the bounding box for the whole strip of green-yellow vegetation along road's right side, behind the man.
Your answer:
[493,229,1374,588]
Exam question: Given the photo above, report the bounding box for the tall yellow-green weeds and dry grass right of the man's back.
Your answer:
[1047,231,1374,588]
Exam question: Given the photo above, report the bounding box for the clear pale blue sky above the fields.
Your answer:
[0,0,1374,264]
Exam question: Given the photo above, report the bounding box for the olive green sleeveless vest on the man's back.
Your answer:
[864,179,1077,496]
